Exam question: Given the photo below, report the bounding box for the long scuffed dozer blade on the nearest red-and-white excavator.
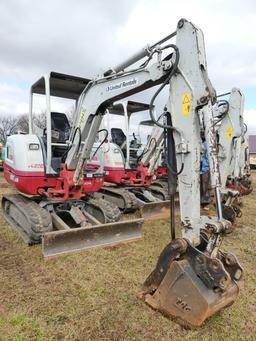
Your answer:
[42,219,143,258]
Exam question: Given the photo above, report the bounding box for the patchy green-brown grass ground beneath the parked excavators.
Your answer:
[0,173,256,341]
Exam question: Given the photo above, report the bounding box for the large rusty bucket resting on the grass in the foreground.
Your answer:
[139,239,243,328]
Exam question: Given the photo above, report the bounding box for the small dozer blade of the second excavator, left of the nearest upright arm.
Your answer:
[140,200,176,220]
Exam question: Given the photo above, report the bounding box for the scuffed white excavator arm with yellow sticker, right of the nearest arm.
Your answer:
[214,88,251,222]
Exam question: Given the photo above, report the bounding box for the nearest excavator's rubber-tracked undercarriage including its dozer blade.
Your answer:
[2,194,143,257]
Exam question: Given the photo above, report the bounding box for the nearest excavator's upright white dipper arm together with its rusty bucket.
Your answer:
[140,21,242,327]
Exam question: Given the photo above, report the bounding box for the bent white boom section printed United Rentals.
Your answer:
[66,55,173,183]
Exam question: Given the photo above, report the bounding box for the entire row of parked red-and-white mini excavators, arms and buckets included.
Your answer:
[2,19,251,326]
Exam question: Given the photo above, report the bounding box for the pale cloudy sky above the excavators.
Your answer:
[0,0,256,134]
